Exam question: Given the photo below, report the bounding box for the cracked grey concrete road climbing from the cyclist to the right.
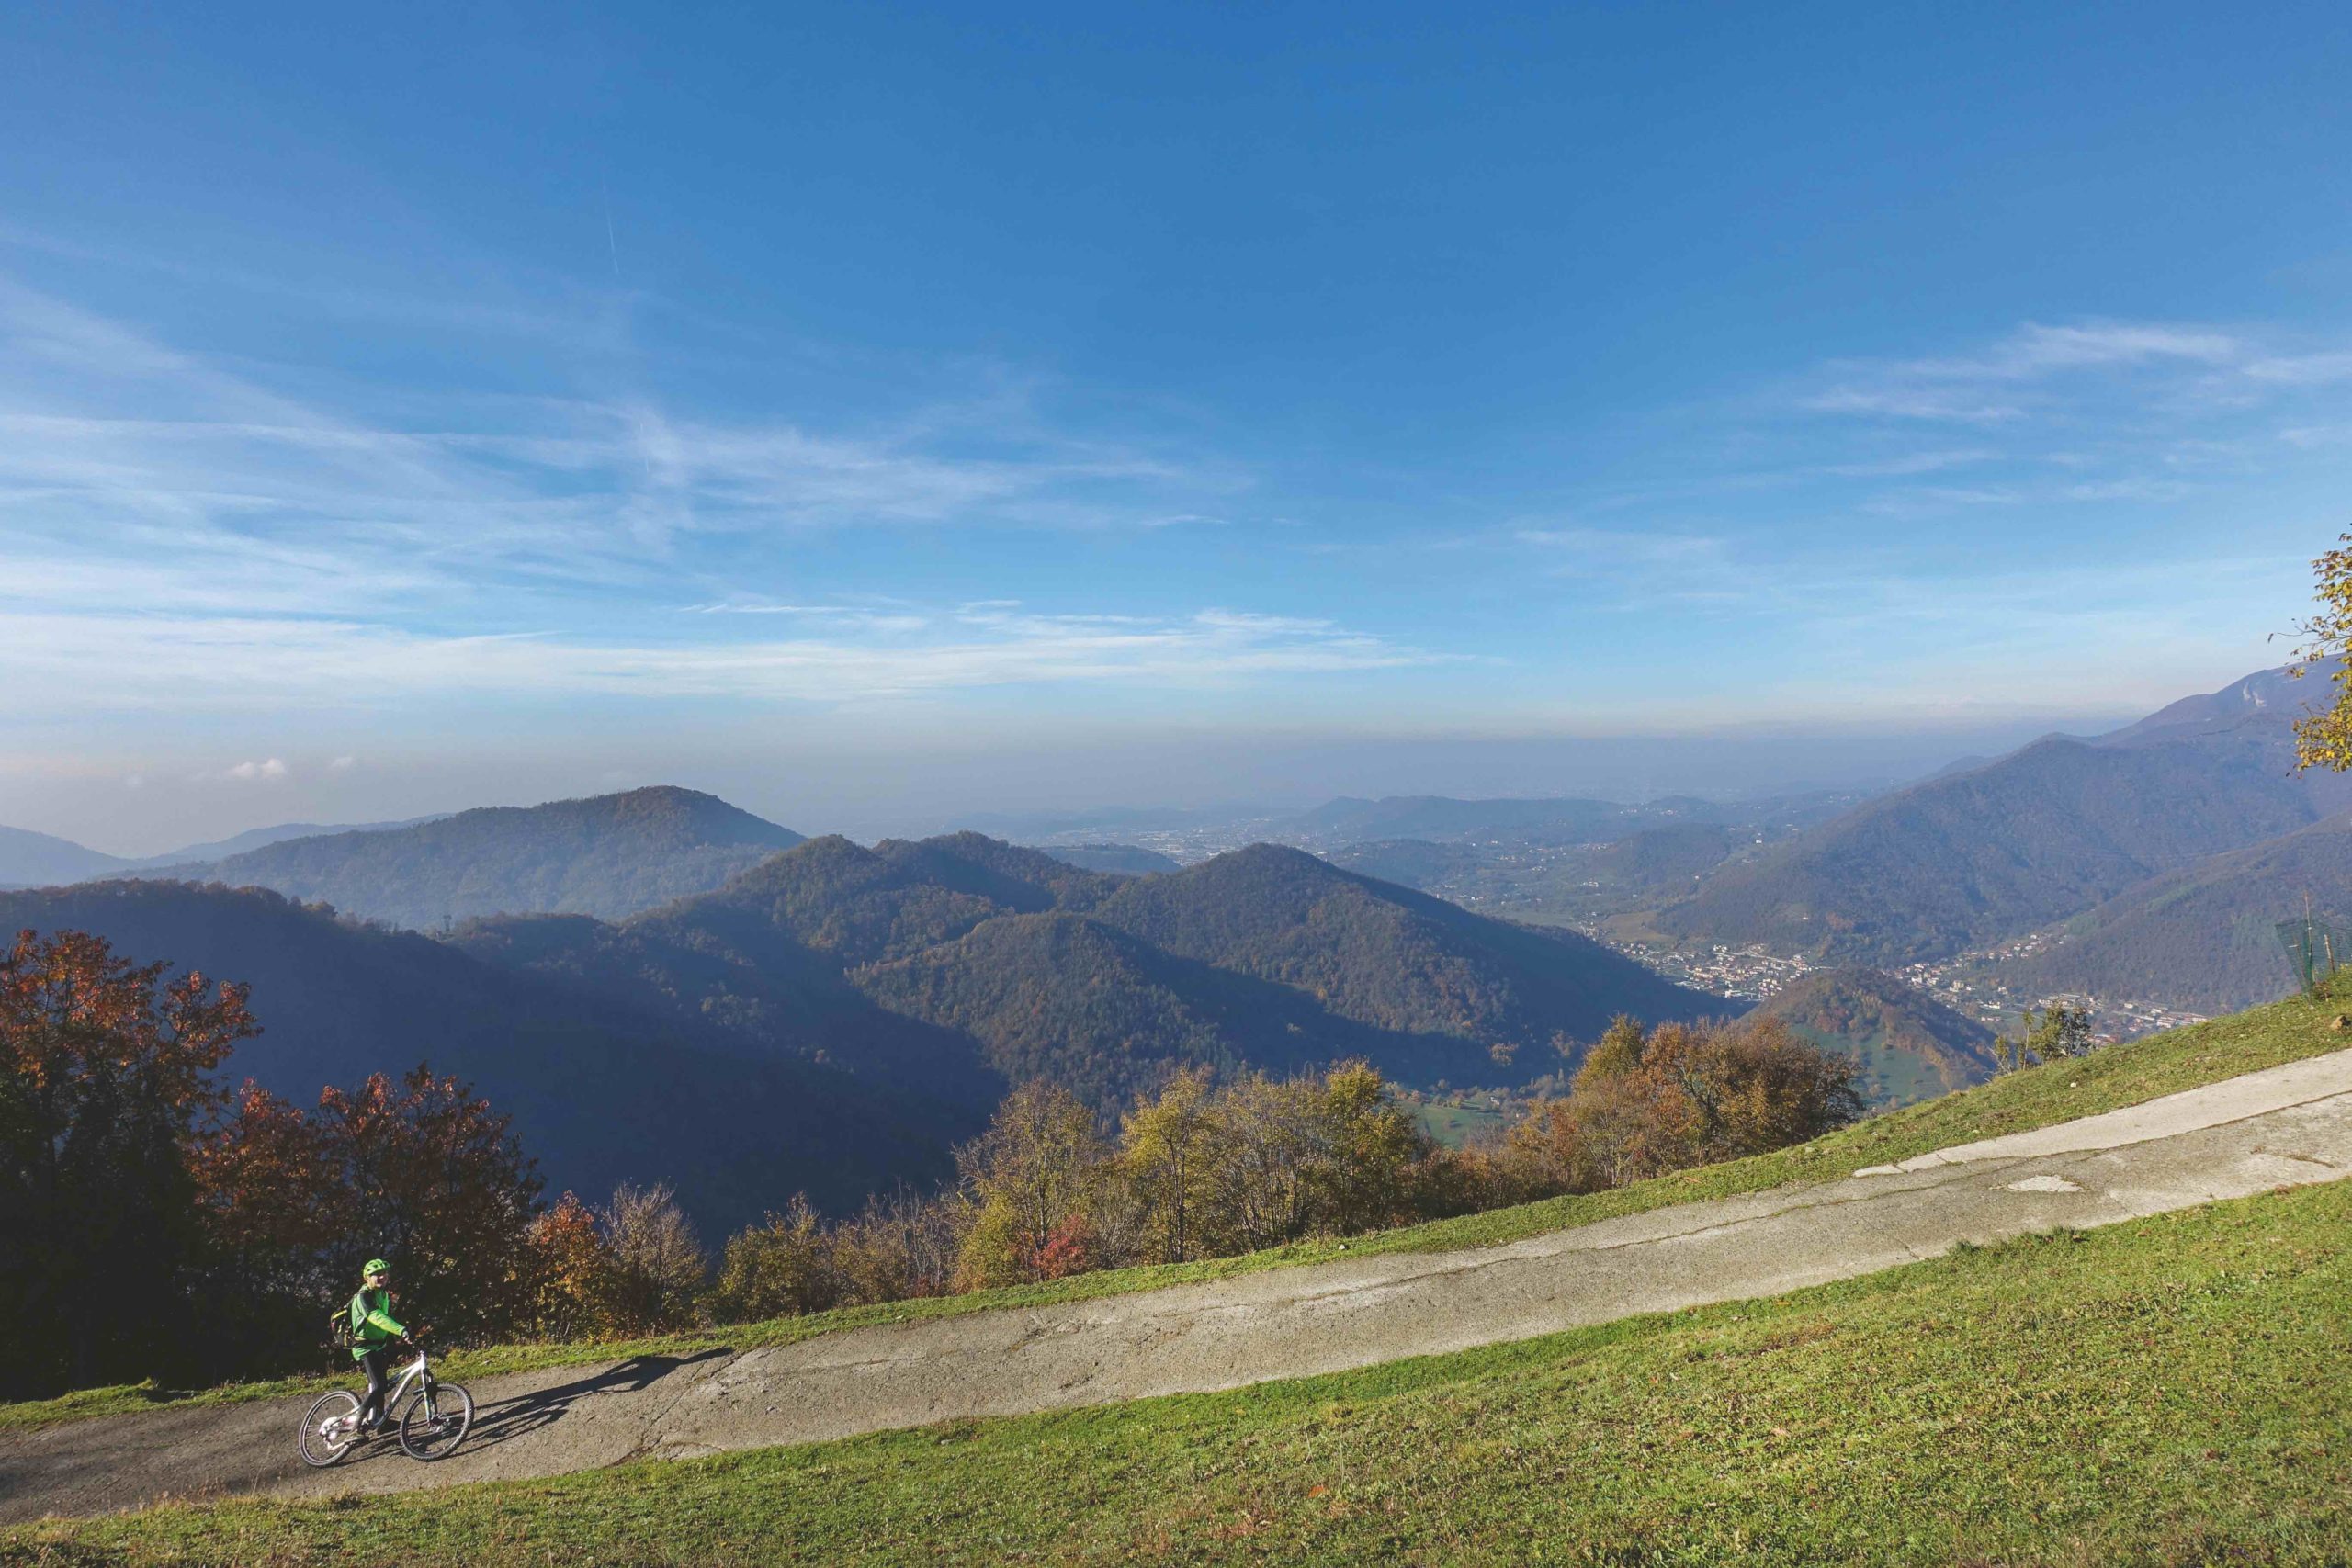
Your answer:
[14,1051,2352,1523]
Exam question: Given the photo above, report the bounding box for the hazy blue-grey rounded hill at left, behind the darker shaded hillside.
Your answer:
[163,785,802,931]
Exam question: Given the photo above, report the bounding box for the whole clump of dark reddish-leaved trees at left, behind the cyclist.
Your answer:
[0,931,576,1394]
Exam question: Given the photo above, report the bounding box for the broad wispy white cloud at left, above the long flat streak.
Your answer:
[0,280,1247,629]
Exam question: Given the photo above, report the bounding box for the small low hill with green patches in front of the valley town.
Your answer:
[1752,968,1996,1107]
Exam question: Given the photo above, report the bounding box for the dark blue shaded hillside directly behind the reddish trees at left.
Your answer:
[0,882,983,1235]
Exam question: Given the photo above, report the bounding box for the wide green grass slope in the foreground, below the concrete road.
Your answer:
[0,1185,2352,1568]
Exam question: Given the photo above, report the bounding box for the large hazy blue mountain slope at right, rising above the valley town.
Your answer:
[1658,670,2352,964]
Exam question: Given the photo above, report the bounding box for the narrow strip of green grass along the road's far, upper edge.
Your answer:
[0,999,2347,1427]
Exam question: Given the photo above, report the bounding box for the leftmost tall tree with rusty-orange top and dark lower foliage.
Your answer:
[0,931,259,1396]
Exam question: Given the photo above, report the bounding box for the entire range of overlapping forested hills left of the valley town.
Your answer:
[0,818,1724,1229]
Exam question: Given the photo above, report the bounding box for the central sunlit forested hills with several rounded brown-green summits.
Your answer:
[454,832,1726,1114]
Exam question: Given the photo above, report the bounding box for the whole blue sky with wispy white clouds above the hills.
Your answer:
[0,5,2352,849]
